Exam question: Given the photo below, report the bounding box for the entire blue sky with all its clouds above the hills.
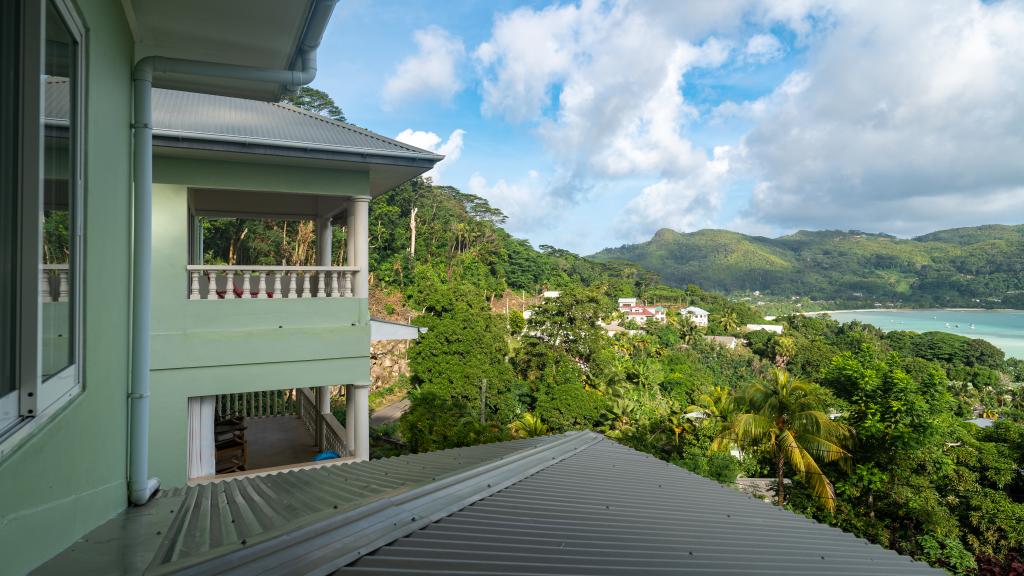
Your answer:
[314,0,1024,253]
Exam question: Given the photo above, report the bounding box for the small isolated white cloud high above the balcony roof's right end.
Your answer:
[383,27,466,107]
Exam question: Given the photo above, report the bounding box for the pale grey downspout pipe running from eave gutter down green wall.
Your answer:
[128,0,337,506]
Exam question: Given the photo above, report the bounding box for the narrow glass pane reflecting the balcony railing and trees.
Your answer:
[39,3,78,380]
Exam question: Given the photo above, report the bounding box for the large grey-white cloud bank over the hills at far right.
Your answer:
[741,0,1024,235]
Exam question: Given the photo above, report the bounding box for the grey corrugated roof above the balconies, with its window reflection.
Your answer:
[45,78,442,162]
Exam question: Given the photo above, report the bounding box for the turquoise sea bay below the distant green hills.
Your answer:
[828,310,1024,359]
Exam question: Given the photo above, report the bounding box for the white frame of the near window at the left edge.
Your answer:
[0,0,86,459]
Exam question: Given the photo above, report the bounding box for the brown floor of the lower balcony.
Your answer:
[246,416,319,471]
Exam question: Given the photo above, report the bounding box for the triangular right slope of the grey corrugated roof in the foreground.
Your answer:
[337,439,941,576]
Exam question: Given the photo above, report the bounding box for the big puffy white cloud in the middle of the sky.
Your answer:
[474,0,745,235]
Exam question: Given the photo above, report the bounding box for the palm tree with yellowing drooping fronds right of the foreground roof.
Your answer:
[712,368,853,510]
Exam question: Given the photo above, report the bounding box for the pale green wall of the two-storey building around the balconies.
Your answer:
[150,157,370,487]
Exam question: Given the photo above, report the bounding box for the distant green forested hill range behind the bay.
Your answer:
[590,224,1024,307]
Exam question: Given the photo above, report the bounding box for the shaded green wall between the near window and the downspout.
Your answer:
[0,0,132,574]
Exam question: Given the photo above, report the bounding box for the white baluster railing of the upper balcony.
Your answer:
[185,265,359,300]
